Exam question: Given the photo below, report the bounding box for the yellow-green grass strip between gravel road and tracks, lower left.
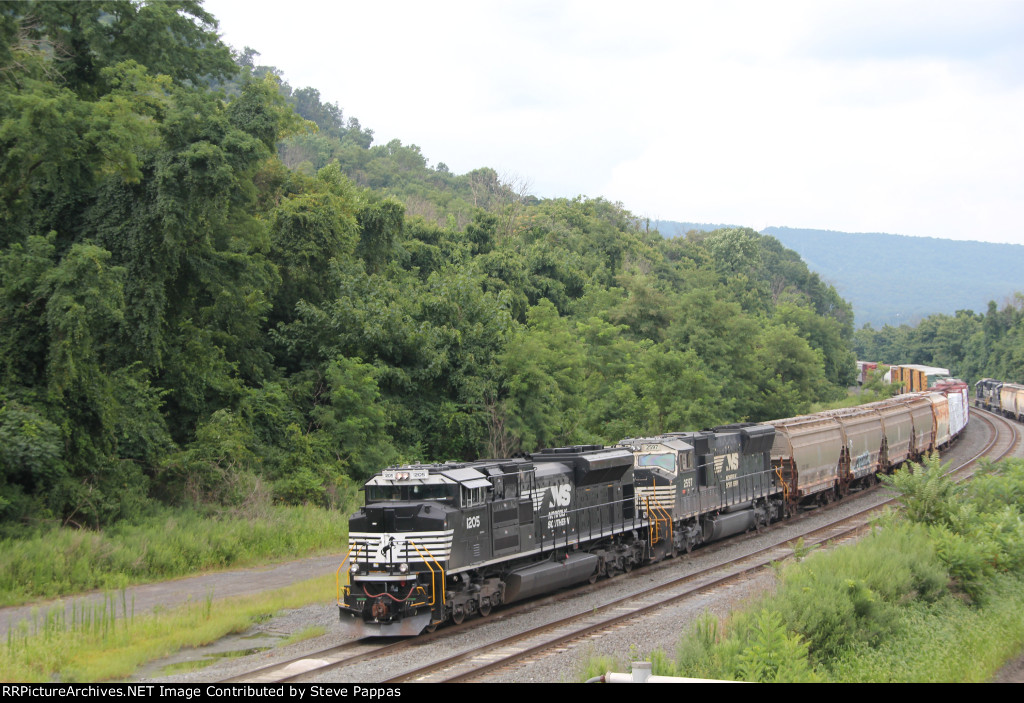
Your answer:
[0,574,335,682]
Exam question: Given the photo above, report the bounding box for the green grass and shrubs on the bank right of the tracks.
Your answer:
[583,459,1024,682]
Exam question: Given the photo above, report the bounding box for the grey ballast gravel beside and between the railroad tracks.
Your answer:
[117,417,1021,684]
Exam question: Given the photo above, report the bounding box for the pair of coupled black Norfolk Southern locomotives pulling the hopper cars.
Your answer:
[338,425,782,636]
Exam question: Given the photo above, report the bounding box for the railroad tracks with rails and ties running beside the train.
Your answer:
[220,408,1020,684]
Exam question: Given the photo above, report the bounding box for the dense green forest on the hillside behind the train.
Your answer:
[0,0,856,529]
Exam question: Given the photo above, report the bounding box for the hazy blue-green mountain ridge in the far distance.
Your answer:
[650,220,1024,327]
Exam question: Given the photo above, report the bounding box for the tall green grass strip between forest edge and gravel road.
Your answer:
[0,507,349,606]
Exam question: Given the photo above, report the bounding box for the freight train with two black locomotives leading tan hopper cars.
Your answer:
[338,383,966,636]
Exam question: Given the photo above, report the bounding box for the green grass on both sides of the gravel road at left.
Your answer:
[0,507,350,682]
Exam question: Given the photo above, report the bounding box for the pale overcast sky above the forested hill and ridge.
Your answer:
[205,0,1024,244]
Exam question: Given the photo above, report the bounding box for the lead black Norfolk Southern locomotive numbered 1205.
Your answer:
[338,445,646,636]
